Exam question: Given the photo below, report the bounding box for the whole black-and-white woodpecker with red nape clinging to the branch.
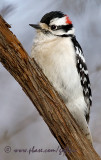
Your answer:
[29,11,92,143]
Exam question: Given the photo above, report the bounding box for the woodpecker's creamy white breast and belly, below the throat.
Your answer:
[31,34,85,113]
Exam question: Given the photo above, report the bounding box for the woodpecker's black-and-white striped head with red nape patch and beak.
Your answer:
[31,11,74,36]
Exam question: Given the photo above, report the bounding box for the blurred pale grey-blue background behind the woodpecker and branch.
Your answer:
[0,0,101,160]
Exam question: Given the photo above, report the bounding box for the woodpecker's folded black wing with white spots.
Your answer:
[72,37,92,122]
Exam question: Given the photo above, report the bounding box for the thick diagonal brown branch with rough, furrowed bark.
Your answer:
[0,17,100,160]
